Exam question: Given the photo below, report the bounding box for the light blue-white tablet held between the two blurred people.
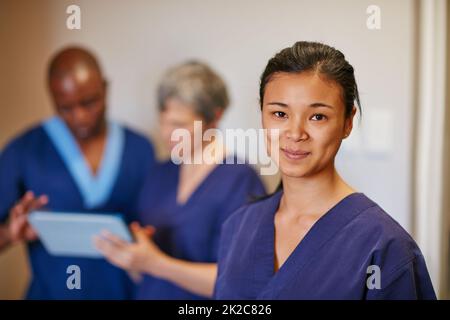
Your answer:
[28,211,132,258]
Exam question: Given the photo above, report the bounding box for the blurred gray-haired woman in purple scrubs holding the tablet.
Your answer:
[97,62,265,299]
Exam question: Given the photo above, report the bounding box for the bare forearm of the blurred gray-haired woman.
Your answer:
[151,256,217,298]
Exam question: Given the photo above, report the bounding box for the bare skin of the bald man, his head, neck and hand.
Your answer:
[0,48,107,250]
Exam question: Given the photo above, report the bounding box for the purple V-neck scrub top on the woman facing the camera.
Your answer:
[214,191,436,299]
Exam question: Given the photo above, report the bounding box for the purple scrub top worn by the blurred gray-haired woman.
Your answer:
[137,158,265,299]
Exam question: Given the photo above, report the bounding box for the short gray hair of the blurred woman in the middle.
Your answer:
[158,61,229,122]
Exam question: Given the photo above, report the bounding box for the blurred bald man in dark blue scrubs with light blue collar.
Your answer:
[0,47,154,299]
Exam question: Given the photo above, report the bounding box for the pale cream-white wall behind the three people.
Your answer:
[0,0,415,298]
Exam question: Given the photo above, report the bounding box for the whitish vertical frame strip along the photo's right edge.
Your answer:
[415,0,447,296]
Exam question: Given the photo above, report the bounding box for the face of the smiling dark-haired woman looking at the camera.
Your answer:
[262,72,356,177]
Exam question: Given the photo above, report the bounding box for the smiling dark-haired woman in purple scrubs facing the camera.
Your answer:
[215,42,436,299]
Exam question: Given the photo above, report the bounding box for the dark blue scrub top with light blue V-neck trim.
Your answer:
[0,118,154,299]
